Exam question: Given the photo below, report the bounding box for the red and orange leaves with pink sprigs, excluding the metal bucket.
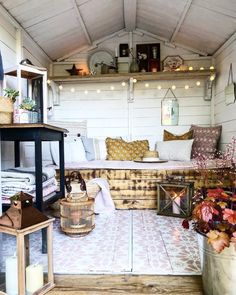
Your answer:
[182,138,236,253]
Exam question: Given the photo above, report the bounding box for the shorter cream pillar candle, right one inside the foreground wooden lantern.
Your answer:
[26,264,44,294]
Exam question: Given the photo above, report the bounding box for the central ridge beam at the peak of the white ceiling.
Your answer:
[124,0,137,32]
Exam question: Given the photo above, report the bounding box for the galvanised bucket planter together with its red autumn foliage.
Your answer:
[182,138,236,295]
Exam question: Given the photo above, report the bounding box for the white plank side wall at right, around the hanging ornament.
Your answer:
[214,39,236,148]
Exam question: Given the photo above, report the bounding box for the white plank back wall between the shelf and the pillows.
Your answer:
[54,80,211,148]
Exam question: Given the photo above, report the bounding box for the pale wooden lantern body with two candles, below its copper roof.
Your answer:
[0,218,55,295]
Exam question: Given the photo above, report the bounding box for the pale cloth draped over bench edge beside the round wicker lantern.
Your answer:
[89,178,115,215]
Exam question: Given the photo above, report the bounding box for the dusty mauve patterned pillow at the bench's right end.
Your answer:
[190,125,222,158]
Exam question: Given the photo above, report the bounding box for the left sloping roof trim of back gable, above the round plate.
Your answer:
[56,29,127,61]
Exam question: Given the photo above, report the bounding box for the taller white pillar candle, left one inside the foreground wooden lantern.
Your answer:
[6,256,18,295]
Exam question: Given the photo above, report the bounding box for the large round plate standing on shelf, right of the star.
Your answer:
[88,49,114,75]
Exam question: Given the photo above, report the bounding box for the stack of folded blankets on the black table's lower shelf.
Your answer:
[1,167,57,204]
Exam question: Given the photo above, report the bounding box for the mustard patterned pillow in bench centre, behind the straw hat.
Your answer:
[106,137,149,161]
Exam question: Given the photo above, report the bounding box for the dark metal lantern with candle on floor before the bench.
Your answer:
[157,179,194,217]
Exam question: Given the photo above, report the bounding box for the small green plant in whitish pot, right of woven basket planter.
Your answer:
[19,97,38,123]
